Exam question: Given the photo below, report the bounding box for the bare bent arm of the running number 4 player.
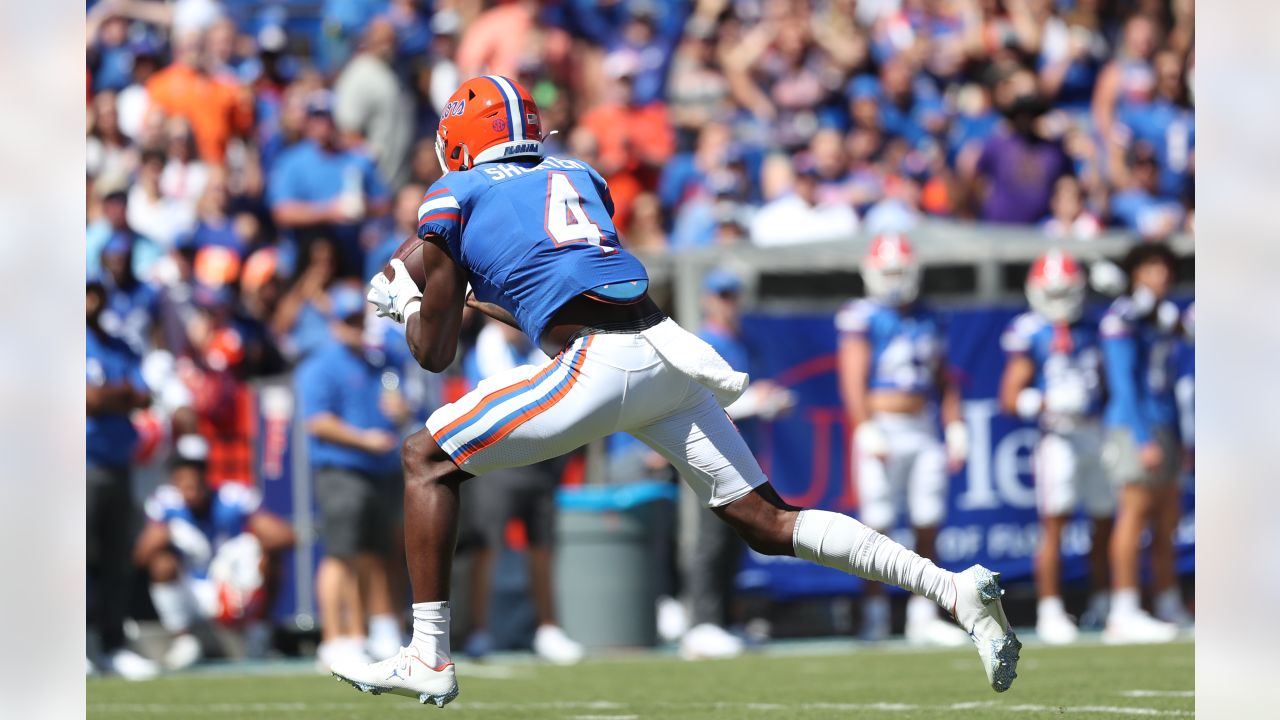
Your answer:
[404,234,468,373]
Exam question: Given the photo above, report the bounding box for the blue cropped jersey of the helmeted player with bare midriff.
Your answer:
[836,299,946,395]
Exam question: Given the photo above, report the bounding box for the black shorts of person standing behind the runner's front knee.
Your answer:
[463,460,563,550]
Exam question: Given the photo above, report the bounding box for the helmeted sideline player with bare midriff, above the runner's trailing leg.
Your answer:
[836,234,969,646]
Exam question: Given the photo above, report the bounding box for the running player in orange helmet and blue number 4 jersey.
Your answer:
[334,76,1021,707]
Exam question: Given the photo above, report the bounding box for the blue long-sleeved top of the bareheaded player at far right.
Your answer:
[1100,297,1179,443]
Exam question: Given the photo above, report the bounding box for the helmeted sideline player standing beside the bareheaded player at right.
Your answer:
[1000,250,1115,644]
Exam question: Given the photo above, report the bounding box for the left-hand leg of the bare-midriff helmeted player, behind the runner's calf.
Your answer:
[854,430,910,642]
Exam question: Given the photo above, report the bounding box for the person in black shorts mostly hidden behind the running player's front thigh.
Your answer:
[463,320,582,665]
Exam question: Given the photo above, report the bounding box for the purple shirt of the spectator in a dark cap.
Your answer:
[978,132,1071,224]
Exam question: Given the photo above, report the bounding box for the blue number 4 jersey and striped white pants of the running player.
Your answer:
[419,156,765,506]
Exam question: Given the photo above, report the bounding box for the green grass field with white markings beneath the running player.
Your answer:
[88,641,1196,720]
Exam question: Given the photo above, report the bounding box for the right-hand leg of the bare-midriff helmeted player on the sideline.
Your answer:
[906,438,969,646]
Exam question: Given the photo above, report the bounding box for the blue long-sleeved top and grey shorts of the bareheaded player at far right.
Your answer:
[1100,297,1181,484]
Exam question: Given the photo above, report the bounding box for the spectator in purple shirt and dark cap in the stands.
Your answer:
[966,69,1071,224]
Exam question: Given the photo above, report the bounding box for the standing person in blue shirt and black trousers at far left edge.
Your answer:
[84,277,157,680]
